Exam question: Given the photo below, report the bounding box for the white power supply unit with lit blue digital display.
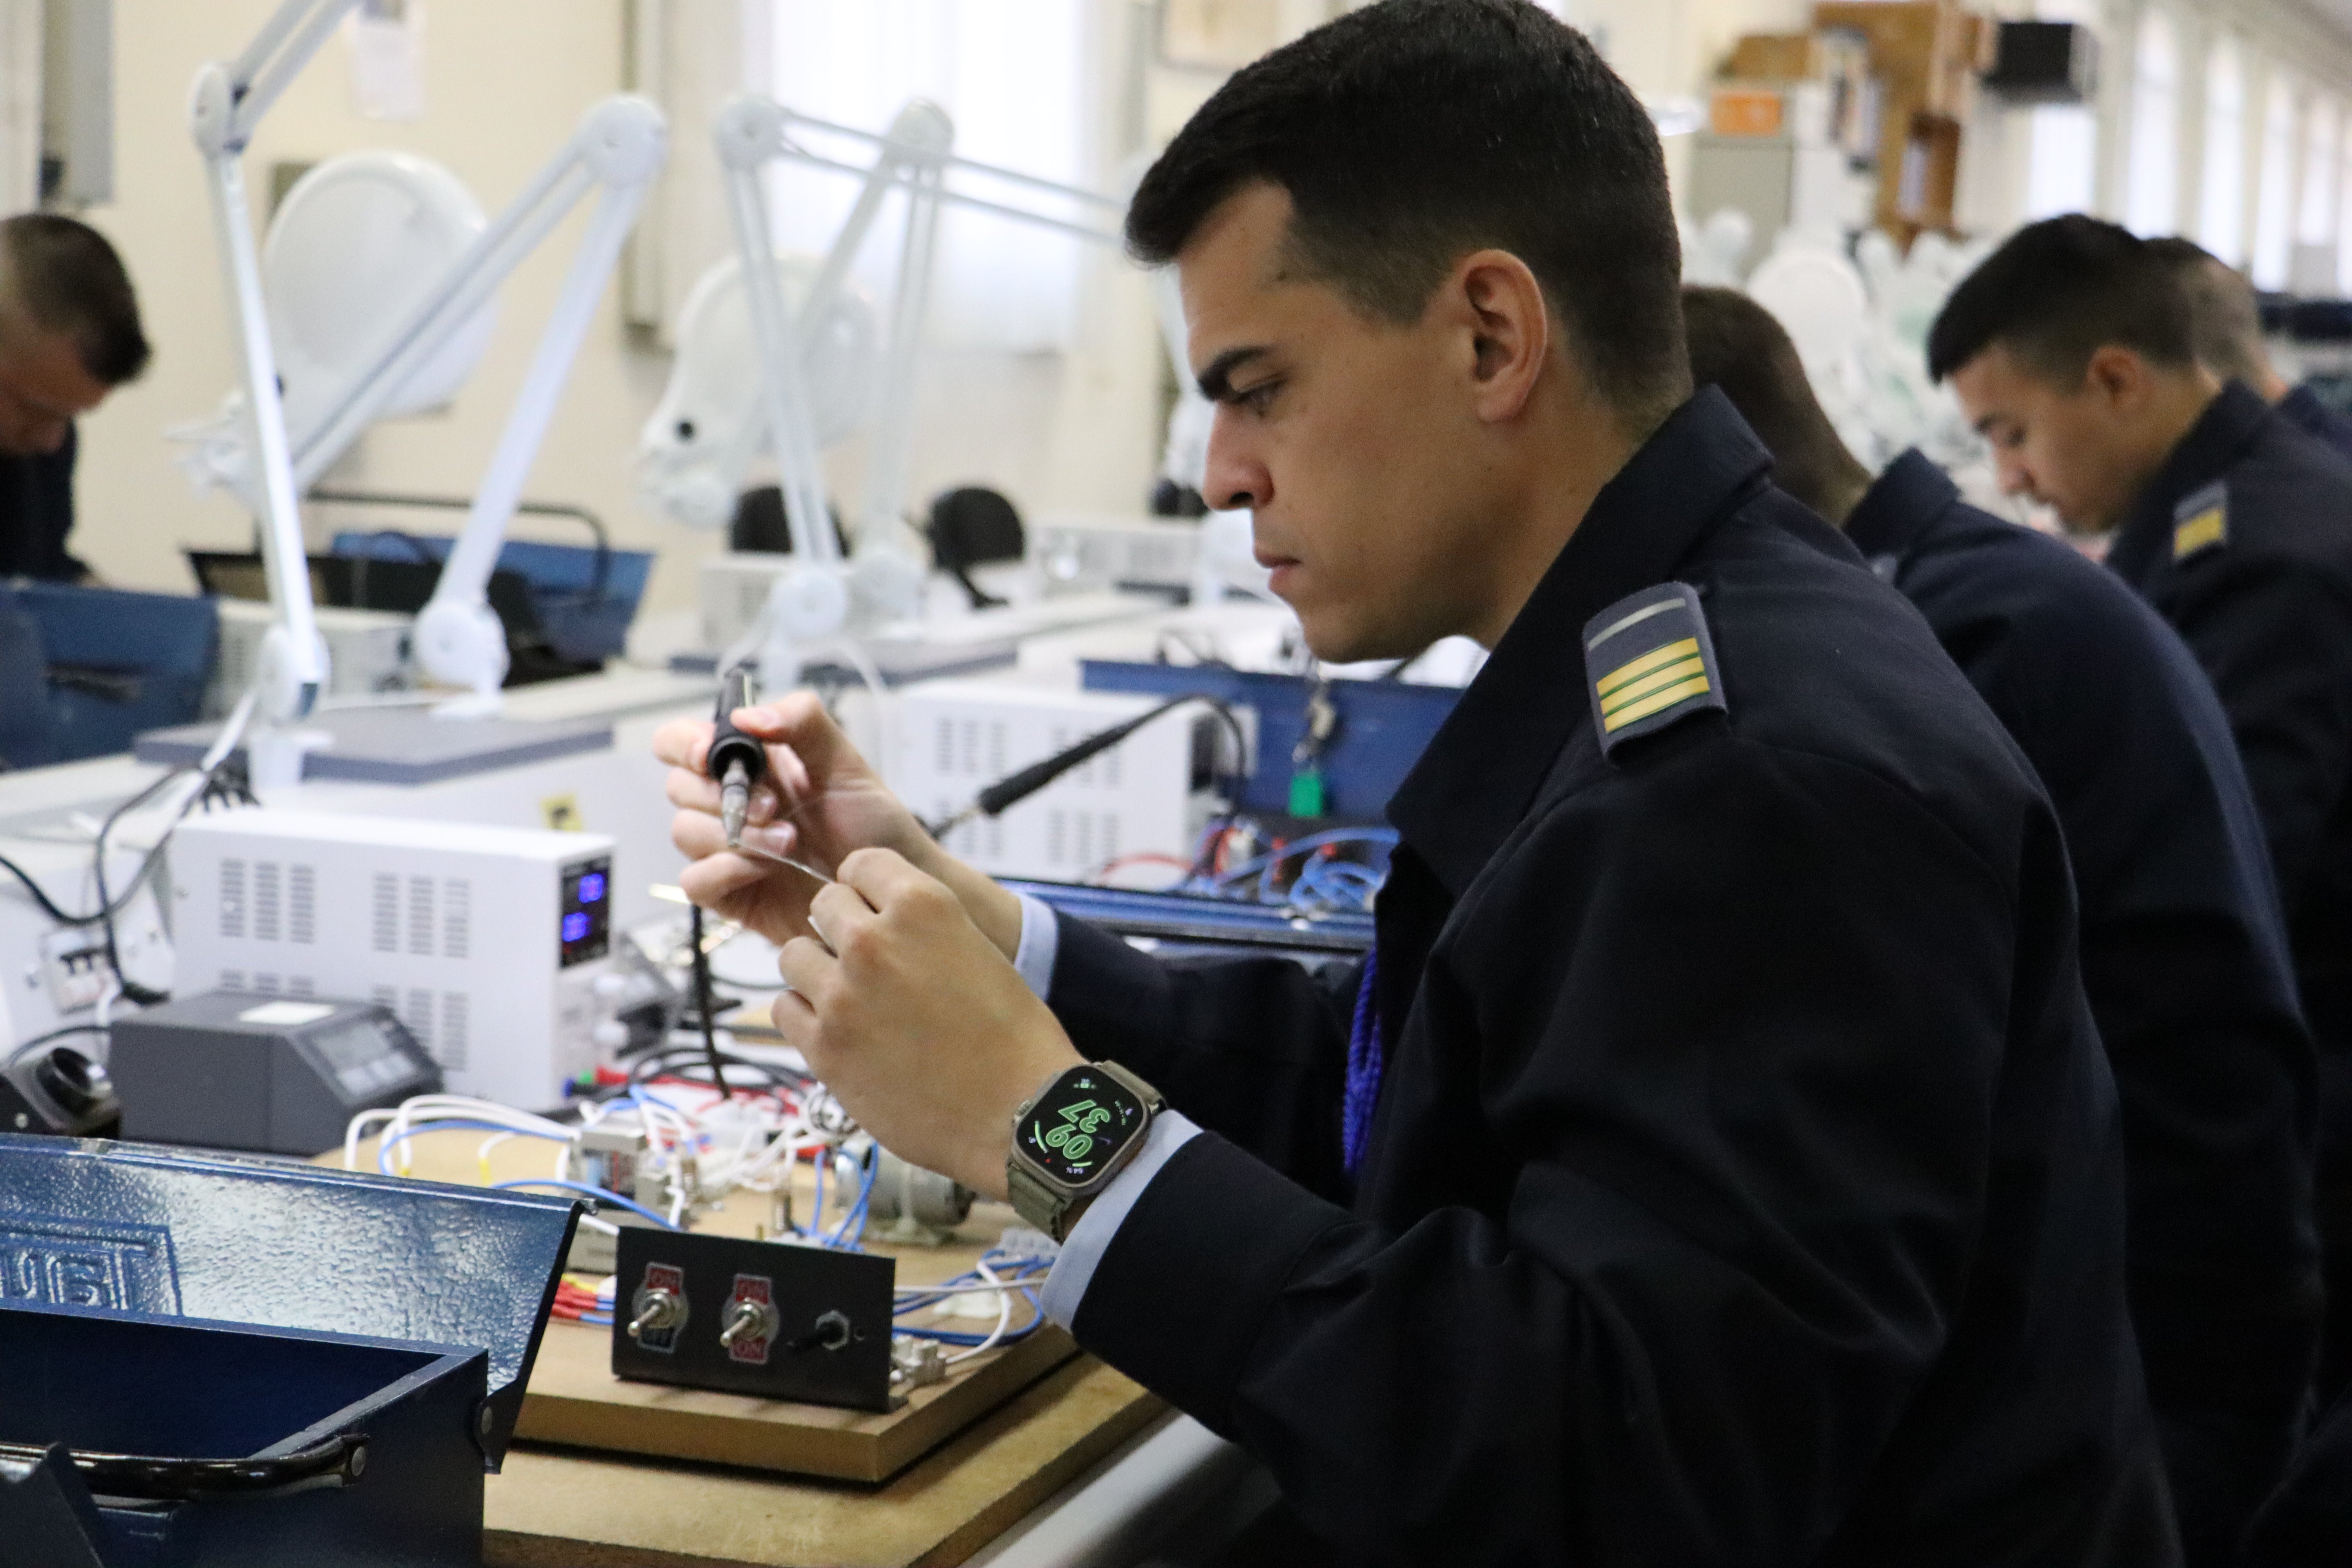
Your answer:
[172,809,612,1110]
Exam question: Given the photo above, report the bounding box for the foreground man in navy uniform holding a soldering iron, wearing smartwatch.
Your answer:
[659,0,2178,1568]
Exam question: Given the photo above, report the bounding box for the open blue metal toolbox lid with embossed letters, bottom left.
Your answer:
[0,1133,581,1465]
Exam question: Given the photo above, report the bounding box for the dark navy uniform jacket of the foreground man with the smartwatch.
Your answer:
[1049,388,2178,1568]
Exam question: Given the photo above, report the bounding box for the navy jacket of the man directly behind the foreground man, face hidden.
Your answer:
[1846,451,2319,1563]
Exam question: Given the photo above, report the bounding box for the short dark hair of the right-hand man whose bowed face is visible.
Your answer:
[1926,212,2197,386]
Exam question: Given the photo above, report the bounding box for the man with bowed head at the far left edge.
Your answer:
[0,212,148,583]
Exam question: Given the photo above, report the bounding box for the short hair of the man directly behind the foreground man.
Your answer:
[1682,287,1870,519]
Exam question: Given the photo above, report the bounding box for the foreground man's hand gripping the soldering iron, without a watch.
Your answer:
[654,691,1021,957]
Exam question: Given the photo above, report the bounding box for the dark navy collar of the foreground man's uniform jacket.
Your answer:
[1388,386,1771,898]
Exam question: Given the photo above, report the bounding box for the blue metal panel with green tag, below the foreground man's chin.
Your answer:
[1080,658,1461,823]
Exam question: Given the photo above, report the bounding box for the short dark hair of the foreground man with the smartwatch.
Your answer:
[1127,0,1689,425]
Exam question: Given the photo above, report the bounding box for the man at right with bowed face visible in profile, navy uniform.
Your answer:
[1929,216,2352,1396]
